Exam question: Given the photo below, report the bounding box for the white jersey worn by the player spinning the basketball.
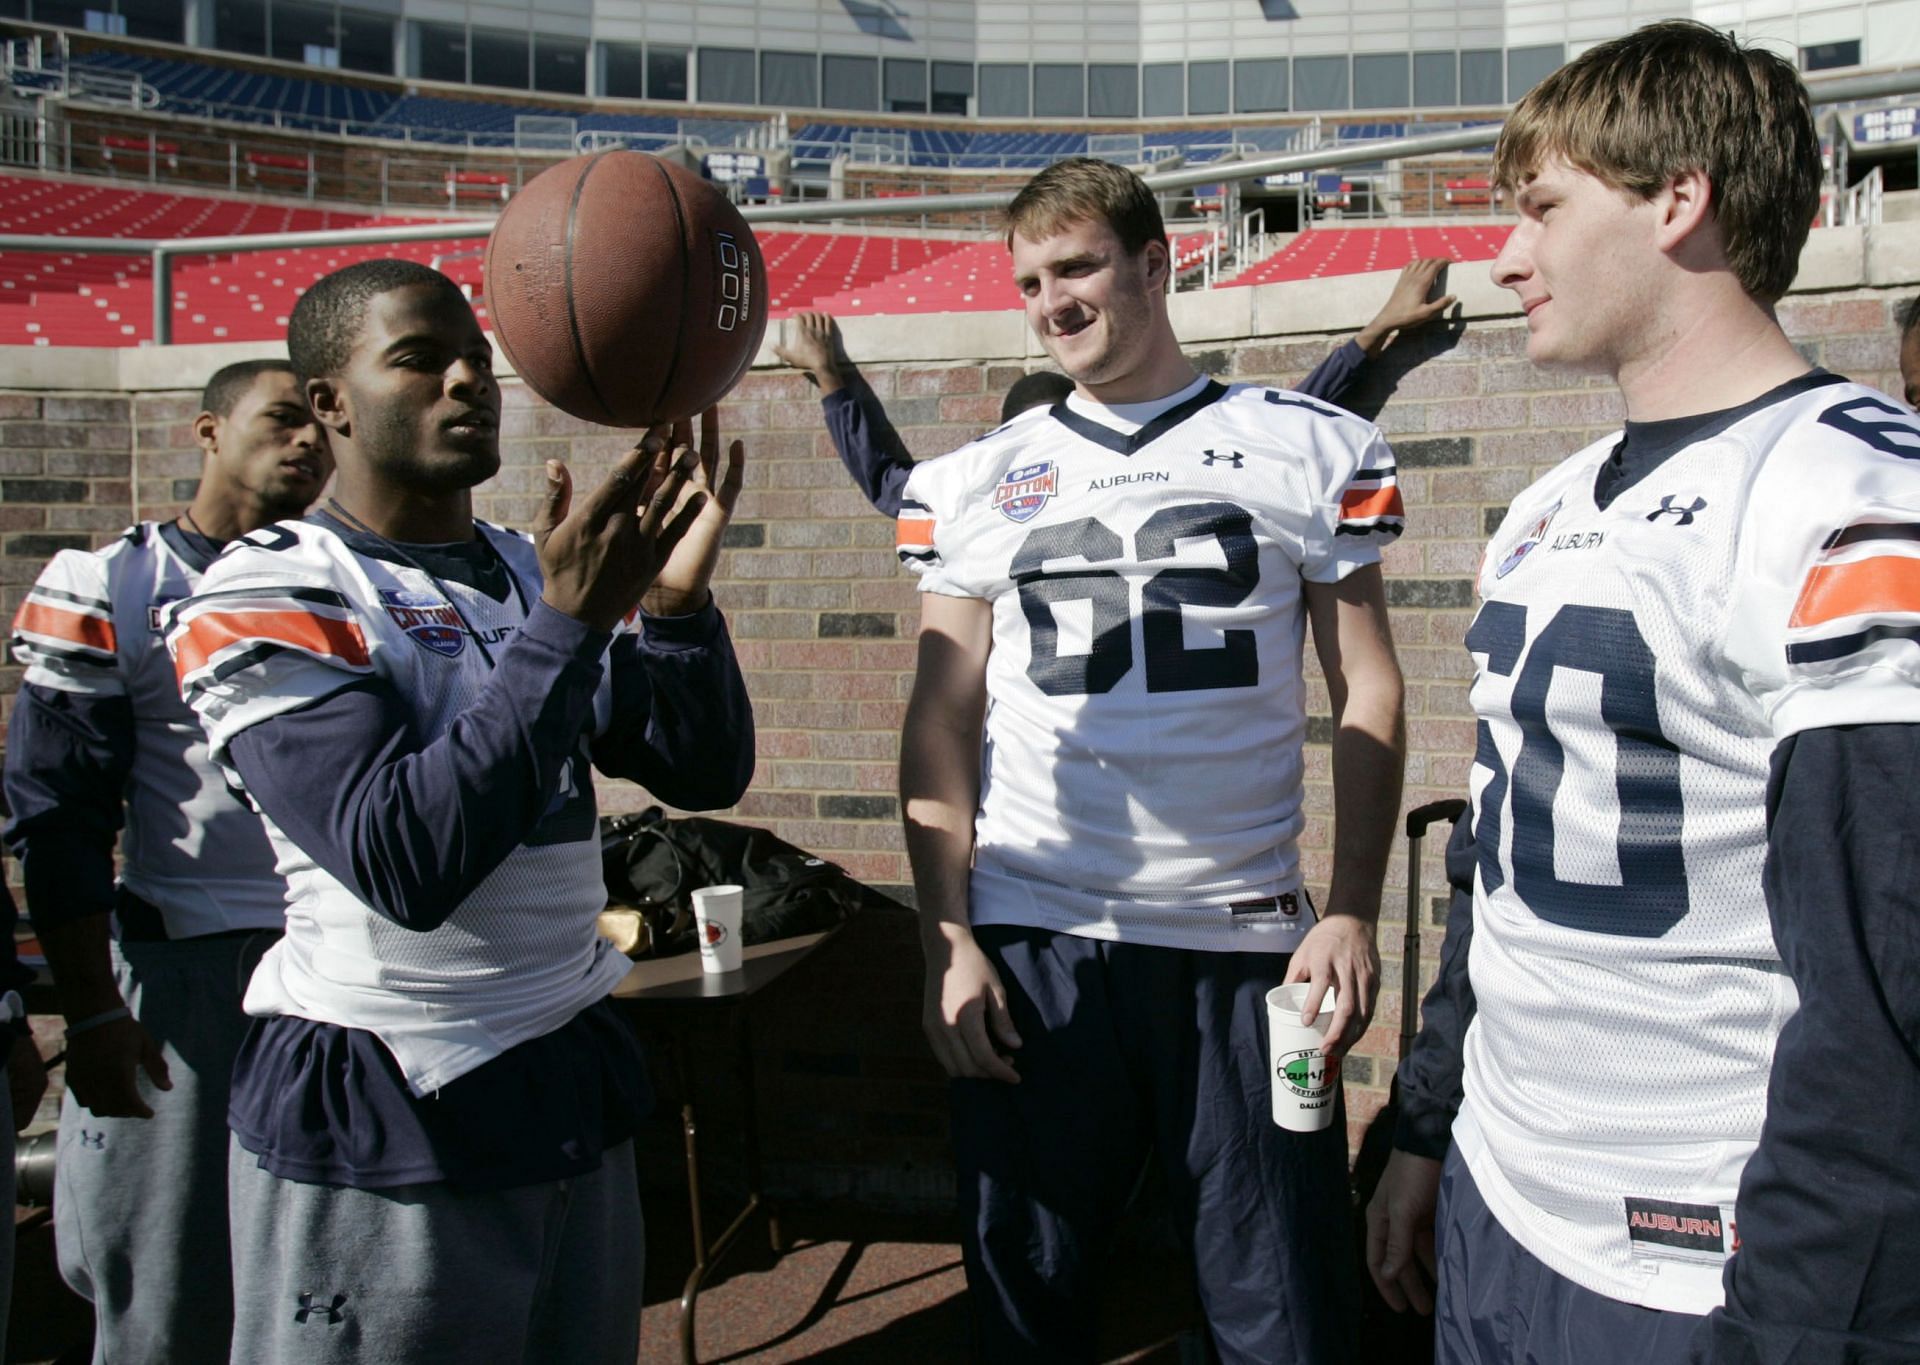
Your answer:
[169,522,628,1094]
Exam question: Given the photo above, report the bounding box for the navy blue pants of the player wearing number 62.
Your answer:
[952,925,1359,1365]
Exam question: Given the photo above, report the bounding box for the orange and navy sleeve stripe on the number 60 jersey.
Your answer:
[1788,522,1920,670]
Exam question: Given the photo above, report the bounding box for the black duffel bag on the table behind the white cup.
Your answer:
[601,806,868,958]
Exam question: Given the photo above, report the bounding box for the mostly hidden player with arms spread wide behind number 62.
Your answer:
[774,257,1453,516]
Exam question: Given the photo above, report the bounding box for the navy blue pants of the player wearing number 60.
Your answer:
[1434,1148,1705,1365]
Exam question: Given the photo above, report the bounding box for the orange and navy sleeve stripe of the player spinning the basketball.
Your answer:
[167,587,372,693]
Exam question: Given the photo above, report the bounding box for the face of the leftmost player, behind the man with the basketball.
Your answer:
[194,371,334,524]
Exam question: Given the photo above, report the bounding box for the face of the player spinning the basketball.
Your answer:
[309,284,499,497]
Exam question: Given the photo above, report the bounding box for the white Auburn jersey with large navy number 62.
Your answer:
[899,380,1404,952]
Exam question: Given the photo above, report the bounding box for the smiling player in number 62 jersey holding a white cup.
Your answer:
[899,157,1404,1365]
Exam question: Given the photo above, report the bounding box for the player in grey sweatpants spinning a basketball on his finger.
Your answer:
[167,261,753,1365]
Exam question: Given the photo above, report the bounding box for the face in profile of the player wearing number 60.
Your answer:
[1492,157,1665,376]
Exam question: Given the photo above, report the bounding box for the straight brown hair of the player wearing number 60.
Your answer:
[1494,19,1820,303]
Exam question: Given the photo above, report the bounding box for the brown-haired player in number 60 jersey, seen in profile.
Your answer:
[1369,21,1920,1365]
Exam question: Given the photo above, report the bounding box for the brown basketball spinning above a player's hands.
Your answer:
[486,150,766,426]
